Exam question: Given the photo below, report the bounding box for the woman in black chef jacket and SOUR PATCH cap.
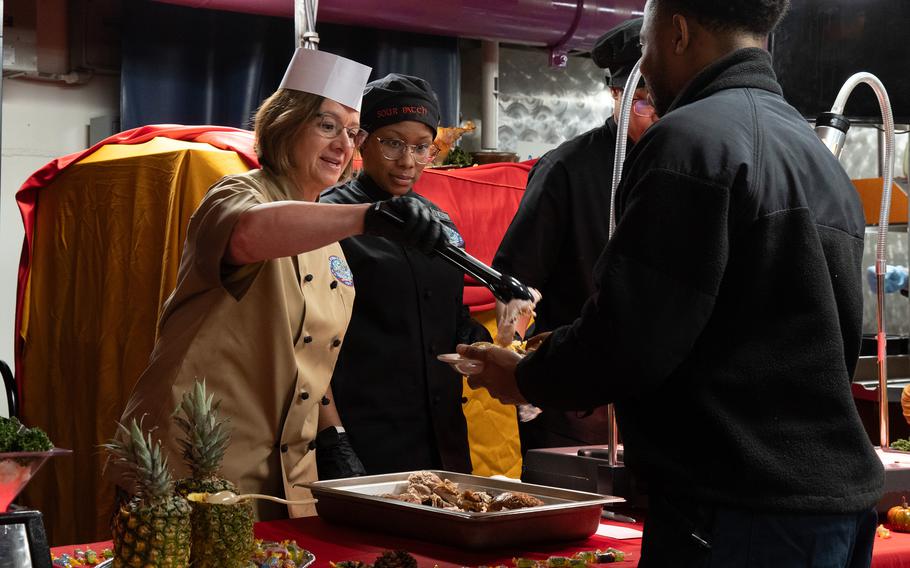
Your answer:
[316,73,490,479]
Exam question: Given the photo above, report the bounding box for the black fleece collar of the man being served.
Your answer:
[667,47,784,113]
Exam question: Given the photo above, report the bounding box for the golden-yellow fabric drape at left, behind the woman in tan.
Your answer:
[20,138,248,545]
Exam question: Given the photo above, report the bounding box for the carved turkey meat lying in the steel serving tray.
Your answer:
[380,471,544,513]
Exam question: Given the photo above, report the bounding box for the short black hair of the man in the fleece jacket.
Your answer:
[655,0,790,36]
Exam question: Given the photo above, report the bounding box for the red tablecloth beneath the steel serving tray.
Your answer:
[53,517,910,568]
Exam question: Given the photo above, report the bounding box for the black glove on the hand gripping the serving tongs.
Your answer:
[363,197,446,254]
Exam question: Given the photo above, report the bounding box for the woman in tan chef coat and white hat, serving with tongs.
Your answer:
[113,49,445,520]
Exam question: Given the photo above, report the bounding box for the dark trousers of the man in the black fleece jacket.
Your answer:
[639,494,877,568]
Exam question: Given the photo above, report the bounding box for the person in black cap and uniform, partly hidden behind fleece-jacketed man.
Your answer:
[493,18,656,453]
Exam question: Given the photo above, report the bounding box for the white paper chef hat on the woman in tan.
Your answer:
[279,47,372,111]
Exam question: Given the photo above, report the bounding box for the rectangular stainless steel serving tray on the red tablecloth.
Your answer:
[304,470,623,549]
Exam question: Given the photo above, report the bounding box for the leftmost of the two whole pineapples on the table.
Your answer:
[104,419,190,568]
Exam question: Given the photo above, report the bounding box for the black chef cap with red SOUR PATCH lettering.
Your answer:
[360,73,439,137]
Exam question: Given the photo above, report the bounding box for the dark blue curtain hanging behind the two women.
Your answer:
[120,0,460,130]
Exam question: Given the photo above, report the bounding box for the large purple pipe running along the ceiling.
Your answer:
[158,0,645,66]
